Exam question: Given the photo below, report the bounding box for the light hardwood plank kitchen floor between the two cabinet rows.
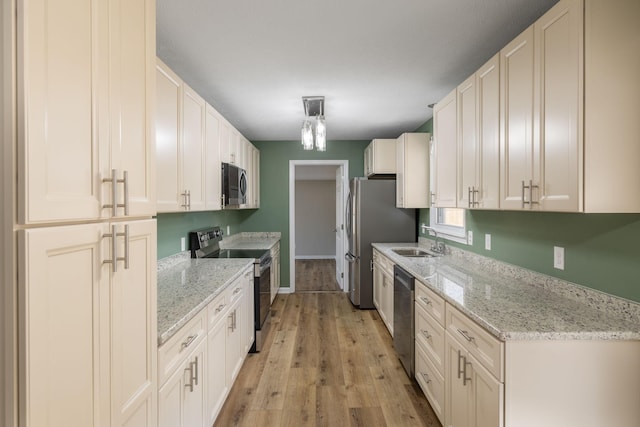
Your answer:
[215,292,440,427]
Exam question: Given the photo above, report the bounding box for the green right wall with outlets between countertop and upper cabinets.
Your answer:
[417,120,640,302]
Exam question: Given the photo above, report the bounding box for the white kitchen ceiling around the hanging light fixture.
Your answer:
[157,0,557,141]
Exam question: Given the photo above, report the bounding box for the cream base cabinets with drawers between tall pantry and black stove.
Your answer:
[158,266,253,427]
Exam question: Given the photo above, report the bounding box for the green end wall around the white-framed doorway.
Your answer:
[236,141,371,287]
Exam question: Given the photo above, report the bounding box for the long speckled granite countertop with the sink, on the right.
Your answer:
[373,242,640,341]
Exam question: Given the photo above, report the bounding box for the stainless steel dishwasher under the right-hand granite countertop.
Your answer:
[393,265,415,379]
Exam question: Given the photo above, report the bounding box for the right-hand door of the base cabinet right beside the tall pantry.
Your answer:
[182,340,207,427]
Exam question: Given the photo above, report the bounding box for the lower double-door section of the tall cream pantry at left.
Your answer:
[18,220,157,427]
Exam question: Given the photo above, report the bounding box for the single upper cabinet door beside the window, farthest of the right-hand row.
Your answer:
[431,90,458,208]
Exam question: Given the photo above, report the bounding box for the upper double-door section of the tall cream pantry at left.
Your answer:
[17,0,155,224]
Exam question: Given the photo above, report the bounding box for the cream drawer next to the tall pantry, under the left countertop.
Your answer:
[158,310,207,384]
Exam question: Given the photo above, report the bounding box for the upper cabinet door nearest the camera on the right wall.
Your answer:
[533,0,584,212]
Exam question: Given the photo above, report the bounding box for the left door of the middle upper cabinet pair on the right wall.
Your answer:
[458,74,481,208]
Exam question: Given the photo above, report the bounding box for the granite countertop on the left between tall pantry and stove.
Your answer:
[158,258,253,347]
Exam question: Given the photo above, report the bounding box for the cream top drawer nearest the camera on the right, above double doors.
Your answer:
[446,304,504,382]
